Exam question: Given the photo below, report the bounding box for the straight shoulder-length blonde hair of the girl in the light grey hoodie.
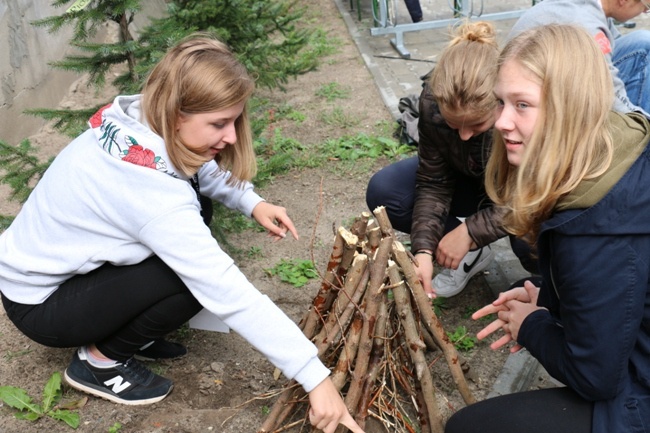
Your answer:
[142,34,257,184]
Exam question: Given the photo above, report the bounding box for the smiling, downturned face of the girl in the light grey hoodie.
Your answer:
[176,102,245,162]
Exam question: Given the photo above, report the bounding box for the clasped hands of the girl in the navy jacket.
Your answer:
[472,281,542,353]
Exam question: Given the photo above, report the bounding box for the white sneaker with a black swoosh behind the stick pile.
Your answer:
[431,245,494,298]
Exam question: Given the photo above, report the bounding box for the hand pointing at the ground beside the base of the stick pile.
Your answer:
[309,377,364,433]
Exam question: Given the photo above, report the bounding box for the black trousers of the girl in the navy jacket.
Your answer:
[445,387,594,433]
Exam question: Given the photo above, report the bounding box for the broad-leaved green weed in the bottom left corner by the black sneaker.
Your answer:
[0,372,87,429]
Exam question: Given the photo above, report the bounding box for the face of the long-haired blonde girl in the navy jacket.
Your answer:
[494,60,542,167]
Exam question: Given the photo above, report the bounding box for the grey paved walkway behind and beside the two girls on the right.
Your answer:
[334,0,650,396]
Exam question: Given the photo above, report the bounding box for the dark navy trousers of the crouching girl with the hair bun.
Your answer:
[366,156,539,274]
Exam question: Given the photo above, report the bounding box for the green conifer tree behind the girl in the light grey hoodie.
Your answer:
[0,0,332,228]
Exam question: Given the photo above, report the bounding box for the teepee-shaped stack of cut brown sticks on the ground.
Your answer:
[258,207,475,433]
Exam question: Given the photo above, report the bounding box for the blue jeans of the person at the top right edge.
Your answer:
[612,30,650,113]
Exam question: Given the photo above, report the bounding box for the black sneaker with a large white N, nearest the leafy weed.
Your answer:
[64,349,174,405]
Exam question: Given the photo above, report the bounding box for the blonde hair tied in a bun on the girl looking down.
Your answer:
[429,21,499,117]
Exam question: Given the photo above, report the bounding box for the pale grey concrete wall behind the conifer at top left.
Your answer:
[0,0,165,144]
